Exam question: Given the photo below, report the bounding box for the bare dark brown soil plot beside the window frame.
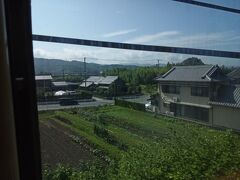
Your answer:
[39,120,97,167]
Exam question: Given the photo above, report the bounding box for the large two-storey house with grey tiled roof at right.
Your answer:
[156,65,240,130]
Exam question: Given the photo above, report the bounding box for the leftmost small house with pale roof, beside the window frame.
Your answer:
[35,75,53,90]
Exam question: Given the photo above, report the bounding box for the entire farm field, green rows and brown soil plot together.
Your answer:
[39,106,240,179]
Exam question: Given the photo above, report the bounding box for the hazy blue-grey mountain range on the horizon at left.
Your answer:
[34,58,138,75]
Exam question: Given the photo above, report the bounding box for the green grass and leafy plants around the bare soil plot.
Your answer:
[40,106,240,179]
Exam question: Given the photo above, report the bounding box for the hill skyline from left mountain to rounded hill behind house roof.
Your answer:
[34,57,233,76]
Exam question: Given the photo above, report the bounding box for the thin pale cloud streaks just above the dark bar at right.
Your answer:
[126,31,240,51]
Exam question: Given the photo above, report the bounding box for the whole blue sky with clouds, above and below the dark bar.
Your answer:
[32,0,240,66]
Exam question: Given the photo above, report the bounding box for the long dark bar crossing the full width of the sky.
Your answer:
[32,34,240,59]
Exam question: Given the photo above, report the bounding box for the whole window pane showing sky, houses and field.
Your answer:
[32,0,240,179]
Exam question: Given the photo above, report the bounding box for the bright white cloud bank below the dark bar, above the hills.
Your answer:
[34,47,202,65]
